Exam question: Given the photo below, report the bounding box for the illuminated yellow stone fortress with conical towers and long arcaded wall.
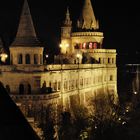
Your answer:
[0,0,117,109]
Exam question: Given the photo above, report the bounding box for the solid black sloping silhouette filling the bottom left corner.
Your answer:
[0,82,40,140]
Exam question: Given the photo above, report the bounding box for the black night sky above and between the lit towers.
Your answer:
[0,0,140,52]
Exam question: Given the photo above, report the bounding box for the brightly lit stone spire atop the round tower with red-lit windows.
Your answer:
[77,0,99,29]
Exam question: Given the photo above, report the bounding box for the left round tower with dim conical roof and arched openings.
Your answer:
[10,0,43,65]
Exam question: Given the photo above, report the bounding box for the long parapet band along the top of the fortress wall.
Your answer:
[0,64,116,72]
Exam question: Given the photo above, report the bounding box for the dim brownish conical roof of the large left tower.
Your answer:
[12,0,40,47]
